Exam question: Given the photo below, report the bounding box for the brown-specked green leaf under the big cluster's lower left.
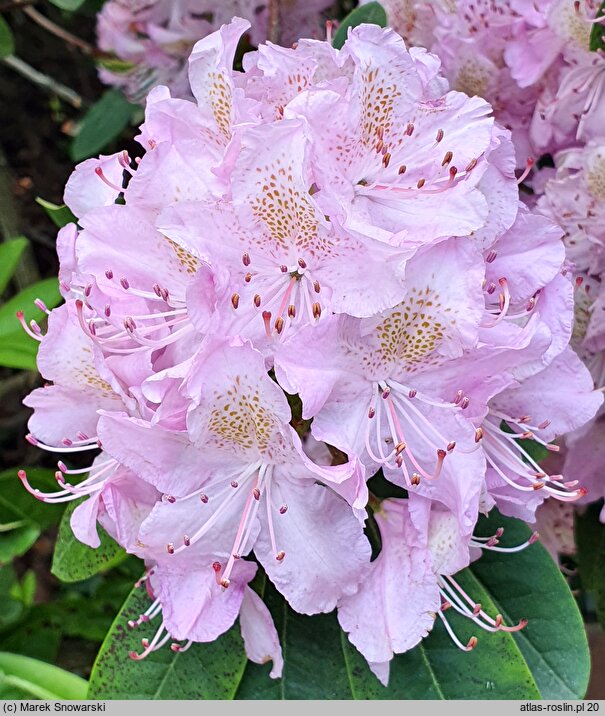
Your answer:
[88,587,246,700]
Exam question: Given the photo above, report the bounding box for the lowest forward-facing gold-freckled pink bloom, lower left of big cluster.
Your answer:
[95,341,369,614]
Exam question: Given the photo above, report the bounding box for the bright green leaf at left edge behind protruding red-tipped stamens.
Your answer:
[0,278,62,370]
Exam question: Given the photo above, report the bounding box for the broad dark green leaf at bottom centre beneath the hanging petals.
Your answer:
[237,580,540,699]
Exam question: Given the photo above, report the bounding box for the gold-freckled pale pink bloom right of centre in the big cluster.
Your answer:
[276,239,483,527]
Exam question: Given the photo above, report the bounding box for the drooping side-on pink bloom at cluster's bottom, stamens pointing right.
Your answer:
[338,499,537,686]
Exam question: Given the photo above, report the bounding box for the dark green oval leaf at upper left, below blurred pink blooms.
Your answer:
[70,90,136,162]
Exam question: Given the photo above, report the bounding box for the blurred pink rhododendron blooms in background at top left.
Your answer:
[97,0,330,102]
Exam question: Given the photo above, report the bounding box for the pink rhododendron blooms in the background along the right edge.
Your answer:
[364,0,605,524]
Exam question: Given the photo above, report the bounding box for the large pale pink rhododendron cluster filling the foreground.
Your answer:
[21,19,602,683]
